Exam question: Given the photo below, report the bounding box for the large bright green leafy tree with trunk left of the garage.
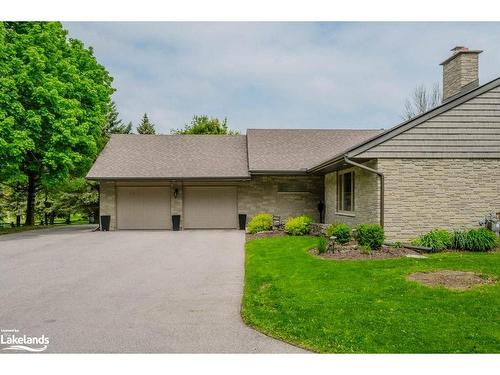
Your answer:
[0,22,113,224]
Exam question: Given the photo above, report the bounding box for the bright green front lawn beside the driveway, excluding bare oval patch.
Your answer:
[242,237,500,353]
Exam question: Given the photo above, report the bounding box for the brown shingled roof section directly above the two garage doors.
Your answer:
[87,134,249,180]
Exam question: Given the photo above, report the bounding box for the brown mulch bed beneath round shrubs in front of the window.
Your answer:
[310,243,420,259]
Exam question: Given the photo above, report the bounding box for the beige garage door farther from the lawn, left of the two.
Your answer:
[117,186,172,229]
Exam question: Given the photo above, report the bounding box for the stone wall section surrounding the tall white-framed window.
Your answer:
[325,160,380,226]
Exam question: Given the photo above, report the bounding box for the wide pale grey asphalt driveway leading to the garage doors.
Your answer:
[0,227,301,353]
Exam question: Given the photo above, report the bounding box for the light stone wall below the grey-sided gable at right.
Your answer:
[378,159,500,241]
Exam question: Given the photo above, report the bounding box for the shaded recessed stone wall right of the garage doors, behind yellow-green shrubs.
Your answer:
[238,176,324,221]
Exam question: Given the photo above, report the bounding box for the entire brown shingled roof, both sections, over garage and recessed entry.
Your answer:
[87,129,380,180]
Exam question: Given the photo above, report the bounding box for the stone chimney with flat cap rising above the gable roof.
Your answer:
[440,46,483,102]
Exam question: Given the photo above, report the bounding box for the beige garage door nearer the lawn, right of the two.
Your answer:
[184,186,238,229]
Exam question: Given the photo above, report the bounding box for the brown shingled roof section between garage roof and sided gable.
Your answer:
[247,129,382,173]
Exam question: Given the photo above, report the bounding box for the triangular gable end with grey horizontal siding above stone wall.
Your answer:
[355,85,500,159]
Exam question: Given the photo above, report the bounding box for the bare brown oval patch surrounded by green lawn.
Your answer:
[407,270,496,290]
